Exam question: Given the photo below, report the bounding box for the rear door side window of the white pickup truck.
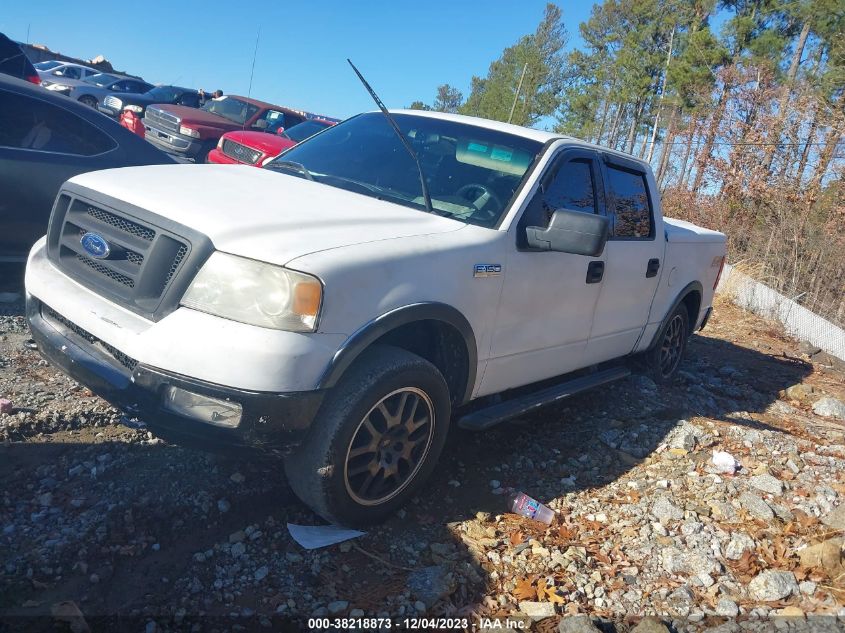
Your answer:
[607,165,653,239]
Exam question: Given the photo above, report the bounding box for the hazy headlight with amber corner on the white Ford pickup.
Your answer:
[182,252,323,332]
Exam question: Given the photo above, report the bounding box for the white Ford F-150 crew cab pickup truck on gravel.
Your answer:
[26,111,725,525]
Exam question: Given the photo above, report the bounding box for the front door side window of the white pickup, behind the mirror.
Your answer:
[517,158,596,248]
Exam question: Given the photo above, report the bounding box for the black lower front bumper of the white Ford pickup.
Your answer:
[26,294,324,450]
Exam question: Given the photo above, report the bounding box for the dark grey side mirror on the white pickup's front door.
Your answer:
[525,209,610,257]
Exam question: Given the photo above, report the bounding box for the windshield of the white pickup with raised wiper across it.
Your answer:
[267,112,542,227]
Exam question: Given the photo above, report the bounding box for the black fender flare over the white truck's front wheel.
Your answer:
[317,301,478,403]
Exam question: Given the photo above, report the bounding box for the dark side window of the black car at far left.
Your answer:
[0,90,116,156]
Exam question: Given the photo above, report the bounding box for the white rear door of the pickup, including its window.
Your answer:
[585,153,666,364]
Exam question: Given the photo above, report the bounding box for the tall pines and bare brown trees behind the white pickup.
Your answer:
[411,0,845,323]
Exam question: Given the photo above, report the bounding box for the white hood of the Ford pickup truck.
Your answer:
[69,165,466,265]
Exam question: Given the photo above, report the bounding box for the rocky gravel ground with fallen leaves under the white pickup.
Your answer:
[0,290,845,633]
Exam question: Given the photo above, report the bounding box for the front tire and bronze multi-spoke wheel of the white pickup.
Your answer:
[285,346,451,527]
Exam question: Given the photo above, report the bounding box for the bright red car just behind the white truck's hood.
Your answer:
[208,118,337,167]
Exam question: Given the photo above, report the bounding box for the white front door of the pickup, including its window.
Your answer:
[477,148,603,395]
